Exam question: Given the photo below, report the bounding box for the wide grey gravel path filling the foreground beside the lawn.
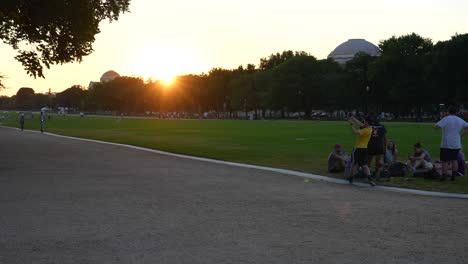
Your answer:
[0,128,468,264]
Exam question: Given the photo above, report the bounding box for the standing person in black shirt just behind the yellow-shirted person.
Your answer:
[367,117,387,175]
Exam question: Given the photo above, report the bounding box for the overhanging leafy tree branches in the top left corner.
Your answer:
[0,0,130,77]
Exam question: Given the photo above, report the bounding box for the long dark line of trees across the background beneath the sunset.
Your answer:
[0,33,468,118]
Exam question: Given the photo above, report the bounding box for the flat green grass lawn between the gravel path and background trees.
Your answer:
[3,114,468,193]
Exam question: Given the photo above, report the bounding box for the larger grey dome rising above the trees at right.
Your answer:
[328,39,381,63]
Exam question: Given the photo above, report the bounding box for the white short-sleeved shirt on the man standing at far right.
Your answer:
[437,115,468,149]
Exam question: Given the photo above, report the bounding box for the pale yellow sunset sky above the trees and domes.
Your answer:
[0,0,468,96]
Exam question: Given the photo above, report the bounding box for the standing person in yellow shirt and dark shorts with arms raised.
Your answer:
[348,116,375,186]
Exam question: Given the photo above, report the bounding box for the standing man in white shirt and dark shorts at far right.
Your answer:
[435,106,468,181]
